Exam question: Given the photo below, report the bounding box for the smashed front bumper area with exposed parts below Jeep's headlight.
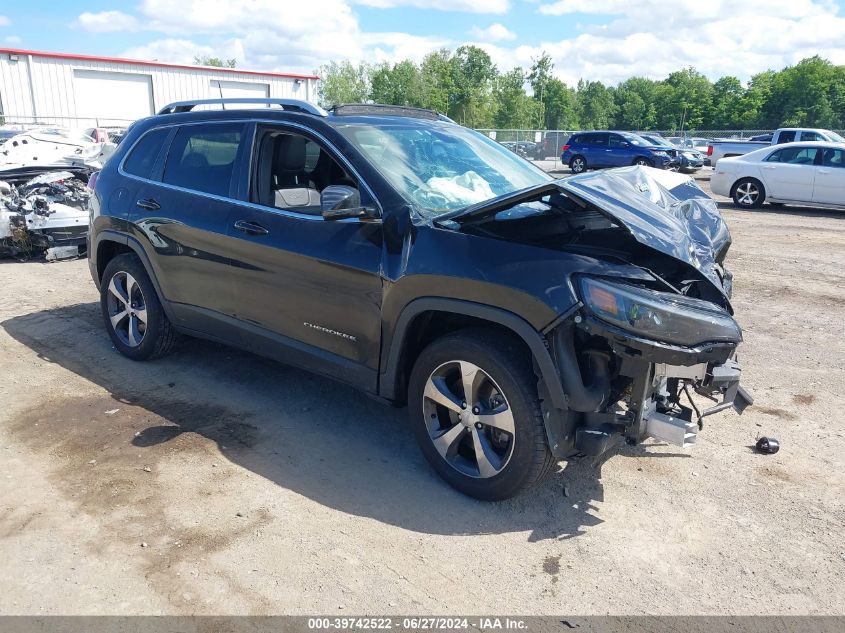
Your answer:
[546,313,753,458]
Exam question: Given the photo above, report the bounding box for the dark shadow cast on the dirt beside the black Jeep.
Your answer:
[2,303,673,541]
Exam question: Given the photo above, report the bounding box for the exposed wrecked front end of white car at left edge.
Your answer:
[0,171,90,261]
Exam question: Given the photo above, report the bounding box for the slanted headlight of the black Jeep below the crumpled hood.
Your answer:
[579,277,742,346]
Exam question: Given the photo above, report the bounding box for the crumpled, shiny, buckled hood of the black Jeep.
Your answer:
[557,167,731,298]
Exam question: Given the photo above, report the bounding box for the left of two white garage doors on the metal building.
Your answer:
[73,70,153,125]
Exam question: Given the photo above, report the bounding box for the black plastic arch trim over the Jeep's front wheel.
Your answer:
[379,297,567,408]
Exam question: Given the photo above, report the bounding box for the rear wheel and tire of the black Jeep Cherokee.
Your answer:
[100,253,176,360]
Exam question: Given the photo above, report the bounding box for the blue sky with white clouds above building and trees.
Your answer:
[0,0,845,85]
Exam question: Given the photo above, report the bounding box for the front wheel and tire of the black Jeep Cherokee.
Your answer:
[408,329,555,501]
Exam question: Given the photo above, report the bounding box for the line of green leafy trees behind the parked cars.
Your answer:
[318,45,845,131]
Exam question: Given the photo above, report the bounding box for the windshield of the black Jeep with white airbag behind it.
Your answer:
[337,120,553,216]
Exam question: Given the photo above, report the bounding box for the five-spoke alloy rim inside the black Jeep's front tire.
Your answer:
[422,360,515,479]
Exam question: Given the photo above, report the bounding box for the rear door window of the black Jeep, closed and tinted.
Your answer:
[162,123,244,196]
